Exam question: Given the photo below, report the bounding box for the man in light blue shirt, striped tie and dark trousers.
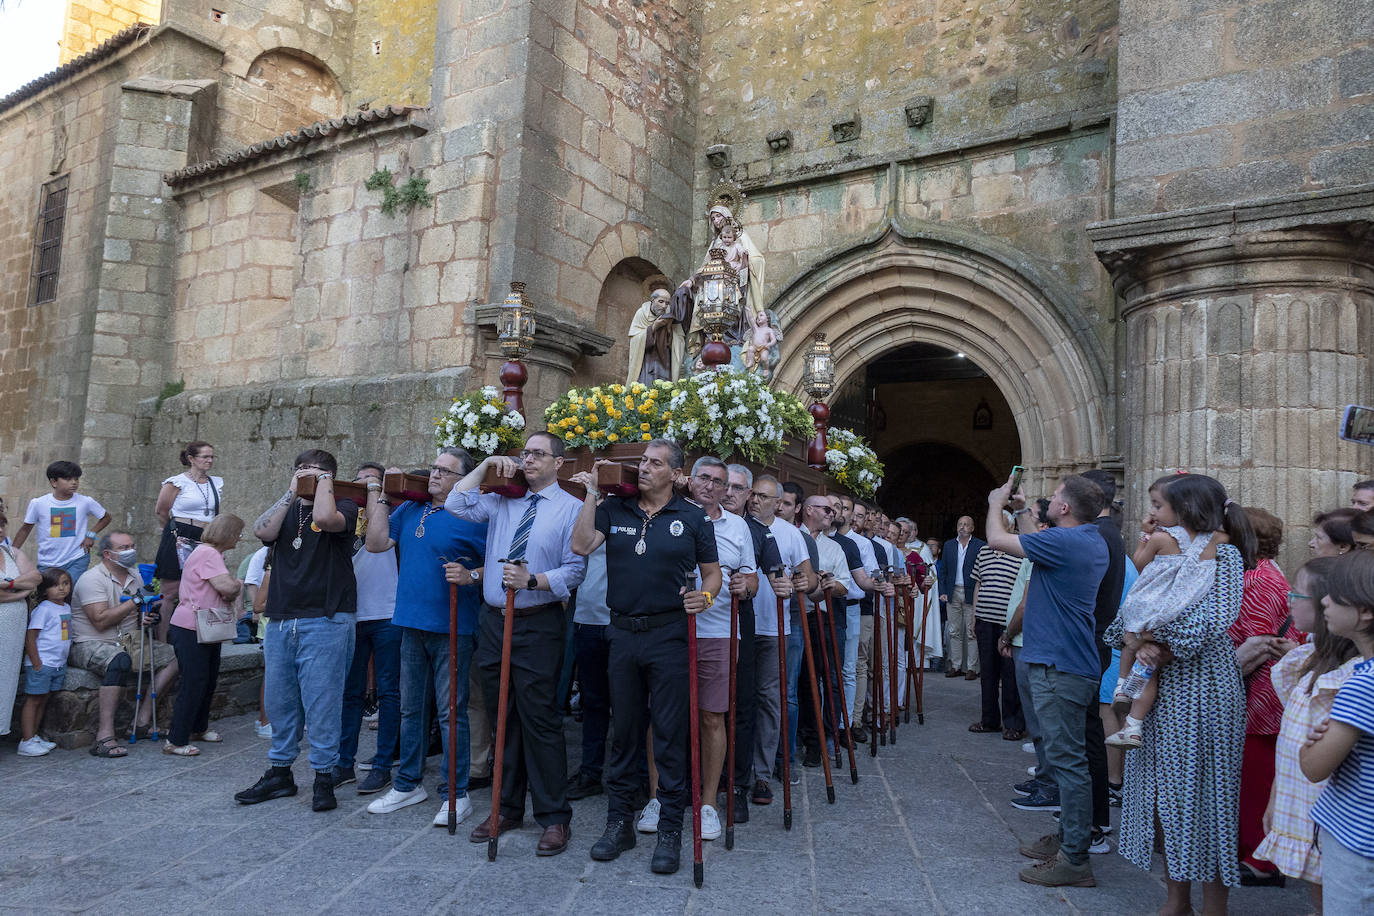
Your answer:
[445,433,587,856]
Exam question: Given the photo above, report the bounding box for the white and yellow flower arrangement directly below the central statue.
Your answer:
[665,369,812,463]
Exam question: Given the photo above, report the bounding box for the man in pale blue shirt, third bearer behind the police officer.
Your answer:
[749,474,816,797]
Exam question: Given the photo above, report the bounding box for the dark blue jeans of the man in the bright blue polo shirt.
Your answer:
[393,626,477,798]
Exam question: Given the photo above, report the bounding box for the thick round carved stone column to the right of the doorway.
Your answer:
[1090,187,1374,571]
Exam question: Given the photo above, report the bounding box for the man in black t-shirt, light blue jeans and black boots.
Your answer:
[234,449,359,812]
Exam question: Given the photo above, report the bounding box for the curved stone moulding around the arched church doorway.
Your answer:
[772,225,1114,477]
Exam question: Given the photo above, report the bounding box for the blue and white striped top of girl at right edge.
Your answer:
[1312,658,1374,858]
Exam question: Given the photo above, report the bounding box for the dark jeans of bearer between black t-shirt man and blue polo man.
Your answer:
[339,619,401,772]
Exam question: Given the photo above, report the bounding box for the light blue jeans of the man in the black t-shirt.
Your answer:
[262,614,354,773]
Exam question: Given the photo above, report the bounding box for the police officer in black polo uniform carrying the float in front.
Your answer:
[572,439,721,875]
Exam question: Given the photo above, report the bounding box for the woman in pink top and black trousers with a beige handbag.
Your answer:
[162,515,243,757]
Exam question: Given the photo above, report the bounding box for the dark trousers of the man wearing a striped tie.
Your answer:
[477,604,573,827]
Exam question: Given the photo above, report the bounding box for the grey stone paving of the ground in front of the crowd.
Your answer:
[0,677,1311,916]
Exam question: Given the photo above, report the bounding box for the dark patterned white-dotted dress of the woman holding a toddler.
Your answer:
[1103,544,1245,886]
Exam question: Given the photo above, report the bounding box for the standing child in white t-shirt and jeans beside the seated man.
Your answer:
[19,569,71,757]
